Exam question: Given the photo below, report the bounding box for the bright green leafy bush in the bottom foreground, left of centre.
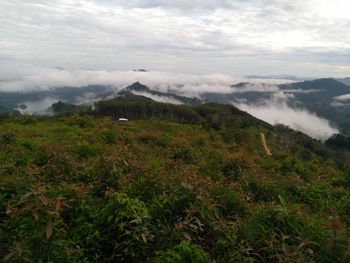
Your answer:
[71,192,153,262]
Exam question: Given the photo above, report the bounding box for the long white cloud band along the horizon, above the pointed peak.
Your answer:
[0,64,290,97]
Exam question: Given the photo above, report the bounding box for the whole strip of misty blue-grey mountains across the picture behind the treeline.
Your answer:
[0,76,350,133]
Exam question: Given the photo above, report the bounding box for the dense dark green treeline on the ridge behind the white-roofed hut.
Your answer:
[94,99,271,130]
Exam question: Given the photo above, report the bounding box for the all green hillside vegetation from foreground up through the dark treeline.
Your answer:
[0,100,350,263]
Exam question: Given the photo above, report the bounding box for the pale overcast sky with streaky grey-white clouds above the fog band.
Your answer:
[0,0,350,77]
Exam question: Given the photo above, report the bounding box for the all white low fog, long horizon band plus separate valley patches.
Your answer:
[0,64,340,140]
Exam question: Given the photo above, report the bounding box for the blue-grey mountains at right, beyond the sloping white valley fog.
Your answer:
[202,78,350,133]
